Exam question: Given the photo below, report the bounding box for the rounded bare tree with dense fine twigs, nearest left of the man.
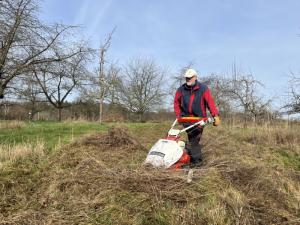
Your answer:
[121,59,164,121]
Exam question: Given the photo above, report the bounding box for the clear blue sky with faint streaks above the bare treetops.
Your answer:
[41,0,300,108]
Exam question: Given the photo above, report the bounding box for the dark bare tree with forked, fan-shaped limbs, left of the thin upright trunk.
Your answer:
[34,48,87,121]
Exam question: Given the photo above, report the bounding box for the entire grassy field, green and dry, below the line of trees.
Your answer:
[0,121,300,224]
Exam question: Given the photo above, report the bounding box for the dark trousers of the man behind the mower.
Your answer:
[186,127,203,163]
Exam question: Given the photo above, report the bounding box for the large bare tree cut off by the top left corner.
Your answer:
[0,0,80,99]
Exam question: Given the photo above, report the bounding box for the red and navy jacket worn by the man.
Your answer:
[174,81,218,118]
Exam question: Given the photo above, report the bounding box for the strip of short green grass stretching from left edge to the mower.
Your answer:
[0,121,168,151]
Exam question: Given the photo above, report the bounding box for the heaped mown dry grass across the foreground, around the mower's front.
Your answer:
[0,125,299,224]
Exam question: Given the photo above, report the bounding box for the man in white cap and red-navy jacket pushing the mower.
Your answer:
[174,69,221,166]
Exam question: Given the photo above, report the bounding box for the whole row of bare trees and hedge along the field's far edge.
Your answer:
[0,0,300,124]
